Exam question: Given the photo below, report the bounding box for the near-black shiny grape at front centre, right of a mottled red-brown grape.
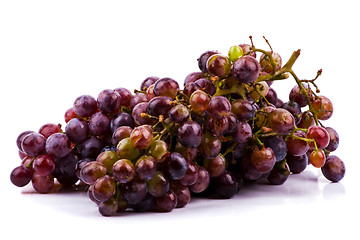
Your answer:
[164,152,188,180]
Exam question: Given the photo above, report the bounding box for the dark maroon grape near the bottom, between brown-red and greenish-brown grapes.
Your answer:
[121,180,147,205]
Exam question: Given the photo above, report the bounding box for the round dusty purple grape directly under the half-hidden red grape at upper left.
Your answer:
[65,118,90,143]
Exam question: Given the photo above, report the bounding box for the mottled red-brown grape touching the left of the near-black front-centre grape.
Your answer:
[135,155,156,181]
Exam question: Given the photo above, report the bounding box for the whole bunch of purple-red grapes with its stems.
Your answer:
[10,37,345,216]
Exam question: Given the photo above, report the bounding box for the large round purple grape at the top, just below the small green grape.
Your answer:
[232,55,260,83]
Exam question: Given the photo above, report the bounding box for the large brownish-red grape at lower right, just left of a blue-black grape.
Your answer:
[251,147,276,173]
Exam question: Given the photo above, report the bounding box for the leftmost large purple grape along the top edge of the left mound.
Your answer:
[73,95,98,117]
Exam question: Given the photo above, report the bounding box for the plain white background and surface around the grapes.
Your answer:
[0,0,360,239]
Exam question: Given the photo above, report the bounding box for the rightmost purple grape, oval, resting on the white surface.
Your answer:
[321,155,345,182]
